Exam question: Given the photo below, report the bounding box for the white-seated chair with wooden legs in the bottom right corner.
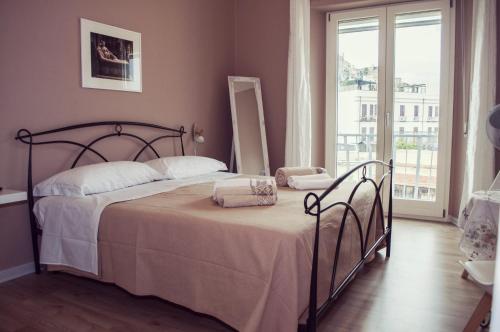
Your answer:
[462,261,495,332]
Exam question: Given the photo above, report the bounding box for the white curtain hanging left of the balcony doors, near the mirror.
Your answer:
[285,0,311,166]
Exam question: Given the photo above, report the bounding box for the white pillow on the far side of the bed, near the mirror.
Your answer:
[145,156,227,179]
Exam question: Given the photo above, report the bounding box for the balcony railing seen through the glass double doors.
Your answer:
[337,134,438,200]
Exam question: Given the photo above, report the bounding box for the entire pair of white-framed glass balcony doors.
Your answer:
[325,1,453,218]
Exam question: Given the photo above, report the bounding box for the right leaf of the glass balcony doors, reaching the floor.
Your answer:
[385,1,453,218]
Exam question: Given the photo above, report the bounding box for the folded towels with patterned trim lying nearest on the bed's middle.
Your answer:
[213,179,278,208]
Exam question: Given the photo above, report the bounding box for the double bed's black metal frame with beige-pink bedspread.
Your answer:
[16,121,392,331]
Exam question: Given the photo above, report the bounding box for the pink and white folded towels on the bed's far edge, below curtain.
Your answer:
[275,167,335,190]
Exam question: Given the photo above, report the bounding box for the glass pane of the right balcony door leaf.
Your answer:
[393,11,441,201]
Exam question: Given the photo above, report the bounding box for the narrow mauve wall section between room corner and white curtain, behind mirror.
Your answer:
[235,0,290,174]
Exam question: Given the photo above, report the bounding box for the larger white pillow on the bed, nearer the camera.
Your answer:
[33,161,162,197]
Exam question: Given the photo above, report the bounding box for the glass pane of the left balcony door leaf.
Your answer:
[336,18,379,176]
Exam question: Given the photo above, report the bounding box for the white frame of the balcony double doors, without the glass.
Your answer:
[325,0,455,221]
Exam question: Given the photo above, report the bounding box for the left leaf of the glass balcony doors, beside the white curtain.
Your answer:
[326,9,385,182]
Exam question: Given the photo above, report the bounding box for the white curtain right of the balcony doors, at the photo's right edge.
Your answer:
[460,0,497,222]
